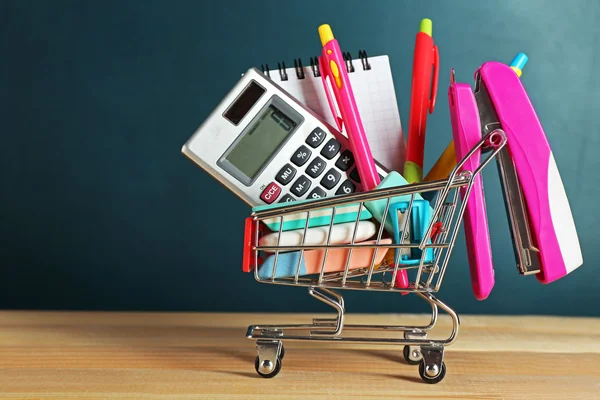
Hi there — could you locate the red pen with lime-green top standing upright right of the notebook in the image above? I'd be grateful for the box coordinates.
[403,18,440,183]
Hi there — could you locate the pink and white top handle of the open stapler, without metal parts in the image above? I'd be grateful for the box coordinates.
[478,62,583,283]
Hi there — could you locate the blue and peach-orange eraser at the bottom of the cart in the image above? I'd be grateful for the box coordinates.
[258,238,392,279]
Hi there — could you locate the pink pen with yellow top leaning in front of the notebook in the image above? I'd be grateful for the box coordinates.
[319,24,380,191]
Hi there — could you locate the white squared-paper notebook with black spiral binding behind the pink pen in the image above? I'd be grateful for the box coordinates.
[261,50,406,173]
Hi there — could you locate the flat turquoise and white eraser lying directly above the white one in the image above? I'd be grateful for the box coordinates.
[252,199,372,231]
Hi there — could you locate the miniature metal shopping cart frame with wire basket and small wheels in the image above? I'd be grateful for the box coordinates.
[245,130,506,383]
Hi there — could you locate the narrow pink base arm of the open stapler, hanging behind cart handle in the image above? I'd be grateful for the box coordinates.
[448,75,495,300]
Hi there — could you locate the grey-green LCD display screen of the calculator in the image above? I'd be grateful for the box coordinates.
[225,104,297,180]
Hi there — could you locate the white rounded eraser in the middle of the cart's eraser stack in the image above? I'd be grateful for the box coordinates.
[258,221,377,250]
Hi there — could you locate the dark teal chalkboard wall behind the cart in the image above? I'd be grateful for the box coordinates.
[0,0,600,316]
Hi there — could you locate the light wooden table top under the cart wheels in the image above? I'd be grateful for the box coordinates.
[0,311,600,399]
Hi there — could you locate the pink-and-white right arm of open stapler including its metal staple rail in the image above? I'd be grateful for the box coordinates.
[474,62,583,283]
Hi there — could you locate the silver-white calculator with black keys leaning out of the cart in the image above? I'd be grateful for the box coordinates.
[181,68,389,207]
